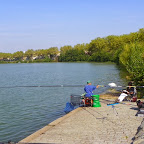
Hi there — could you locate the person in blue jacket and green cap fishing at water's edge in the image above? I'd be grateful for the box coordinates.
[84,81,99,97]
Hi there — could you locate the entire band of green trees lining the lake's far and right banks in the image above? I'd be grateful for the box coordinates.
[0,29,144,88]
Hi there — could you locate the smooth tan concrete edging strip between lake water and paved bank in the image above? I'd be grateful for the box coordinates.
[18,107,82,144]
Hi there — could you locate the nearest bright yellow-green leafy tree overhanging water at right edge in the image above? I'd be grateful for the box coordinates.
[120,43,144,83]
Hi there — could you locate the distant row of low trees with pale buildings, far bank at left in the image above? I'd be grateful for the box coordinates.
[0,47,59,63]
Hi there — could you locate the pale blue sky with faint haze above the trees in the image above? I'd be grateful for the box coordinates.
[0,0,144,53]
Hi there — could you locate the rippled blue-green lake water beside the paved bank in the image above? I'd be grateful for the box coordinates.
[0,63,125,142]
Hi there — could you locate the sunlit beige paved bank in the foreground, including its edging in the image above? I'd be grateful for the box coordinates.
[18,102,143,144]
